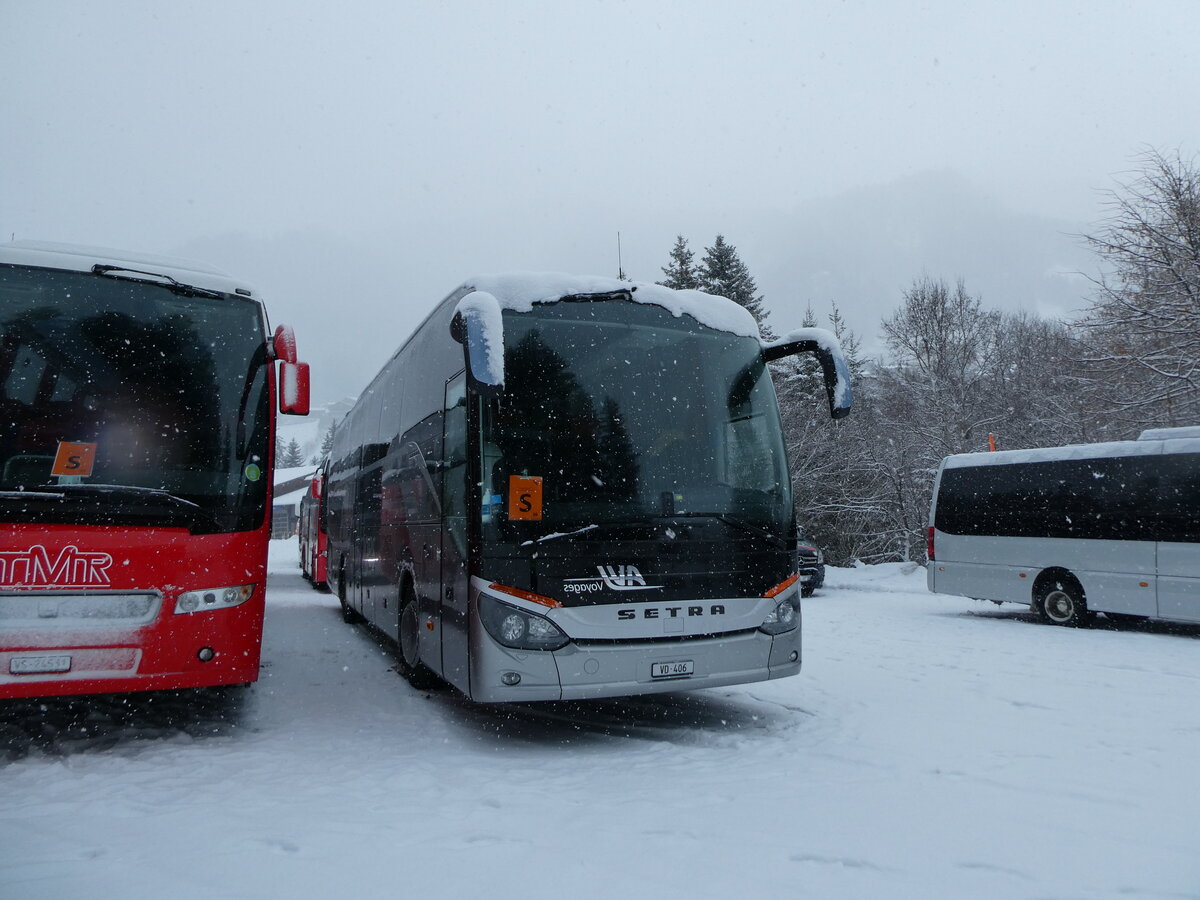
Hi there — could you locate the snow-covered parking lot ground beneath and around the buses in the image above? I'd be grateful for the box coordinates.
[0,540,1200,900]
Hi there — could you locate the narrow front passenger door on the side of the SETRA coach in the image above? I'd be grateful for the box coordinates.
[440,372,470,691]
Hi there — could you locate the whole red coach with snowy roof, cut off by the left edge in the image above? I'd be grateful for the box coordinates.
[0,242,308,698]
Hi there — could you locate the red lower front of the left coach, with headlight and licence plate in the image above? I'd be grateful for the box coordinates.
[0,526,266,698]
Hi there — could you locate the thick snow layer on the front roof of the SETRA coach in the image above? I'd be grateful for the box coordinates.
[463,272,761,340]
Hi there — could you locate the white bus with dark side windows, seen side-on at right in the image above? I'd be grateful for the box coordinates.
[928,427,1200,625]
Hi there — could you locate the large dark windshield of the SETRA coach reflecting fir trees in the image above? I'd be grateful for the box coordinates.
[480,299,792,541]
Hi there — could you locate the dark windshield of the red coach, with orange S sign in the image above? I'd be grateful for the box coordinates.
[0,265,269,533]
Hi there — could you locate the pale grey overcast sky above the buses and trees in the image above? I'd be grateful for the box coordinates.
[0,0,1200,397]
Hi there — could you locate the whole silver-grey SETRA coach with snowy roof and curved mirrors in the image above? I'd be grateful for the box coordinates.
[325,275,850,702]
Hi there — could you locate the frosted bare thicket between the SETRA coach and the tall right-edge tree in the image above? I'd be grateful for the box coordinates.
[773,276,1103,563]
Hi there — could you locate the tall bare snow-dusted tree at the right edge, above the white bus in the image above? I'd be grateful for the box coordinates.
[1080,150,1200,428]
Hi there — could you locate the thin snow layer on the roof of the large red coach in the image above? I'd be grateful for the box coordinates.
[0,241,257,296]
